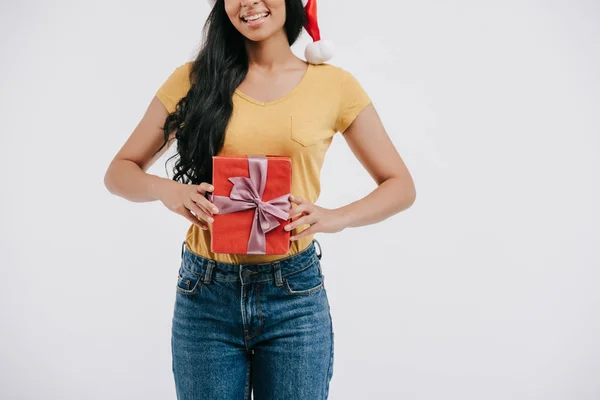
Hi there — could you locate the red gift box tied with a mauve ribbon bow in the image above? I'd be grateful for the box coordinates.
[208,156,292,254]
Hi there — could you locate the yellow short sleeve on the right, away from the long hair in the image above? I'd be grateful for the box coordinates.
[335,68,371,133]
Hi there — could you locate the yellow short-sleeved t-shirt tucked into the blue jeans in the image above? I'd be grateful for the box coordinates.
[156,61,371,264]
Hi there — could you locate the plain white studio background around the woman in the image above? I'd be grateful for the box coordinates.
[0,0,600,400]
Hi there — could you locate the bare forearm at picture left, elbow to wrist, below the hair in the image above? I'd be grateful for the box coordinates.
[104,160,173,203]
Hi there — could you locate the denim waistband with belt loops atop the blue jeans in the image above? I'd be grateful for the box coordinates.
[181,239,323,284]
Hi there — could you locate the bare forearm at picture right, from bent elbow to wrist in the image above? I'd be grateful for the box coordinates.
[335,178,416,228]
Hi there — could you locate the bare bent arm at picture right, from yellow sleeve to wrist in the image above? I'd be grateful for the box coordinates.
[333,104,416,227]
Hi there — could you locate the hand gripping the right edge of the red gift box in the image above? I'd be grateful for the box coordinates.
[284,194,345,240]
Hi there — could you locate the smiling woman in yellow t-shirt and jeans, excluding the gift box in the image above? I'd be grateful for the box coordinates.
[105,0,415,400]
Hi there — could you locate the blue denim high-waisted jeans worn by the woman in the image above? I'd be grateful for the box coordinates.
[171,240,333,400]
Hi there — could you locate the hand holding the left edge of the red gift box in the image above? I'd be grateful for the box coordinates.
[159,180,219,230]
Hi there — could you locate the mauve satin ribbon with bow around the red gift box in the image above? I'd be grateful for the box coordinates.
[208,156,292,254]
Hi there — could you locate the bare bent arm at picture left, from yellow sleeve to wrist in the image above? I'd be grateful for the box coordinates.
[104,97,175,202]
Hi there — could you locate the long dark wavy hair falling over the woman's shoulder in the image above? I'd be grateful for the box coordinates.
[155,0,306,185]
